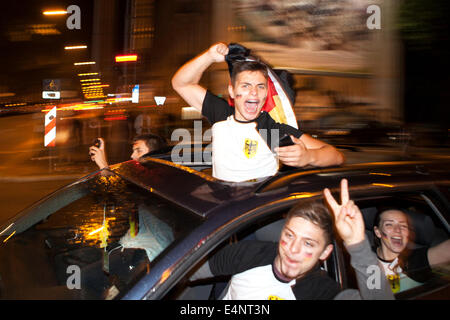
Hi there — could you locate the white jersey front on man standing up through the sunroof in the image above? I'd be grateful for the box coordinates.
[212,115,278,182]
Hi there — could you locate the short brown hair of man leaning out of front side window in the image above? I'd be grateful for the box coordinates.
[286,201,334,245]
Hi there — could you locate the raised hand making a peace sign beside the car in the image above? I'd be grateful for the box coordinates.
[323,179,365,245]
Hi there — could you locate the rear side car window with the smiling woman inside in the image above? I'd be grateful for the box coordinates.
[347,193,450,299]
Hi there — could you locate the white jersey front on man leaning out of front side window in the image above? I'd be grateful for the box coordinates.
[223,264,296,300]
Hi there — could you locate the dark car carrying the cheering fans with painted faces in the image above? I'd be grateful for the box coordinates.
[0,158,450,299]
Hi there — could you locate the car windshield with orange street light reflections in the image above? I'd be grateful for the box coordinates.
[0,171,200,299]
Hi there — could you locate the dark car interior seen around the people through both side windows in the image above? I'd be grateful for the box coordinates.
[164,193,450,300]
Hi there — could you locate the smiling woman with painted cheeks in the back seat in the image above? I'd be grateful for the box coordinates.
[373,209,450,293]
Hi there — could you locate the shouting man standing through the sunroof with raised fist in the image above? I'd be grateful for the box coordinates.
[172,43,344,182]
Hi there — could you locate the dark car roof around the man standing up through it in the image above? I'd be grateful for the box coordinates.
[112,158,450,218]
